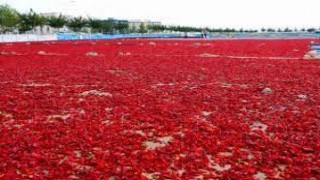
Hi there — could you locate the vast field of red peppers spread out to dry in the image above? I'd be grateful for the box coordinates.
[0,39,320,180]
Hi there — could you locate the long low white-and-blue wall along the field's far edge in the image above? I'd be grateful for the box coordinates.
[0,33,320,42]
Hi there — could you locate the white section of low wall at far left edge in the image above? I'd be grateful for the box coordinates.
[0,34,58,42]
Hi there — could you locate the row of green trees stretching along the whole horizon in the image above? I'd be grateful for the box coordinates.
[0,4,318,34]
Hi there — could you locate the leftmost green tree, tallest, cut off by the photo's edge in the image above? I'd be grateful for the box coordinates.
[0,5,19,33]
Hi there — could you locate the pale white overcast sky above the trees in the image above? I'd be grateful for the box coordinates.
[0,0,320,29]
